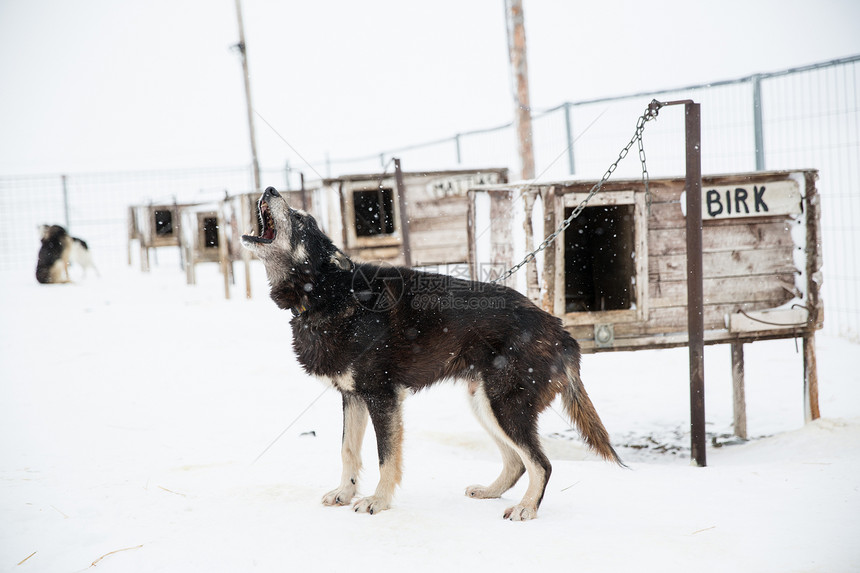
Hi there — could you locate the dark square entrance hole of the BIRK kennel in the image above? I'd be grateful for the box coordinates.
[564,205,636,312]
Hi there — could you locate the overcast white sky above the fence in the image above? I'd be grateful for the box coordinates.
[0,0,860,175]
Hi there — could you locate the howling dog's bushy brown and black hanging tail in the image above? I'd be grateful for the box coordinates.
[561,348,627,468]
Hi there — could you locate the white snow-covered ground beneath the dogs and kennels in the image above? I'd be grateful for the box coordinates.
[0,259,860,572]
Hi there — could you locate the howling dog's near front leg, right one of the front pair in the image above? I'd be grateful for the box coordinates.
[353,389,406,514]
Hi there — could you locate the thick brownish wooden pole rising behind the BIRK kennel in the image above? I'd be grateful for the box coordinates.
[505,0,535,179]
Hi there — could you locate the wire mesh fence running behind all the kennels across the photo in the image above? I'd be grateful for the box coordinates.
[0,56,860,338]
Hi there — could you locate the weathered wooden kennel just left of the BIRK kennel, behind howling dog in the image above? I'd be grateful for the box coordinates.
[318,168,508,266]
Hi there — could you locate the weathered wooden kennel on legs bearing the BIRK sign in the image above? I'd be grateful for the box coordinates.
[469,170,823,437]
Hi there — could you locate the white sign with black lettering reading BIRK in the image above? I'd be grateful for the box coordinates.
[702,180,803,220]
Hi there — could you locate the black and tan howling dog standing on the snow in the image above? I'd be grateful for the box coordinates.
[242,187,623,521]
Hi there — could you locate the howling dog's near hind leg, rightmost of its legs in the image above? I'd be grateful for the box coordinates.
[467,385,552,521]
